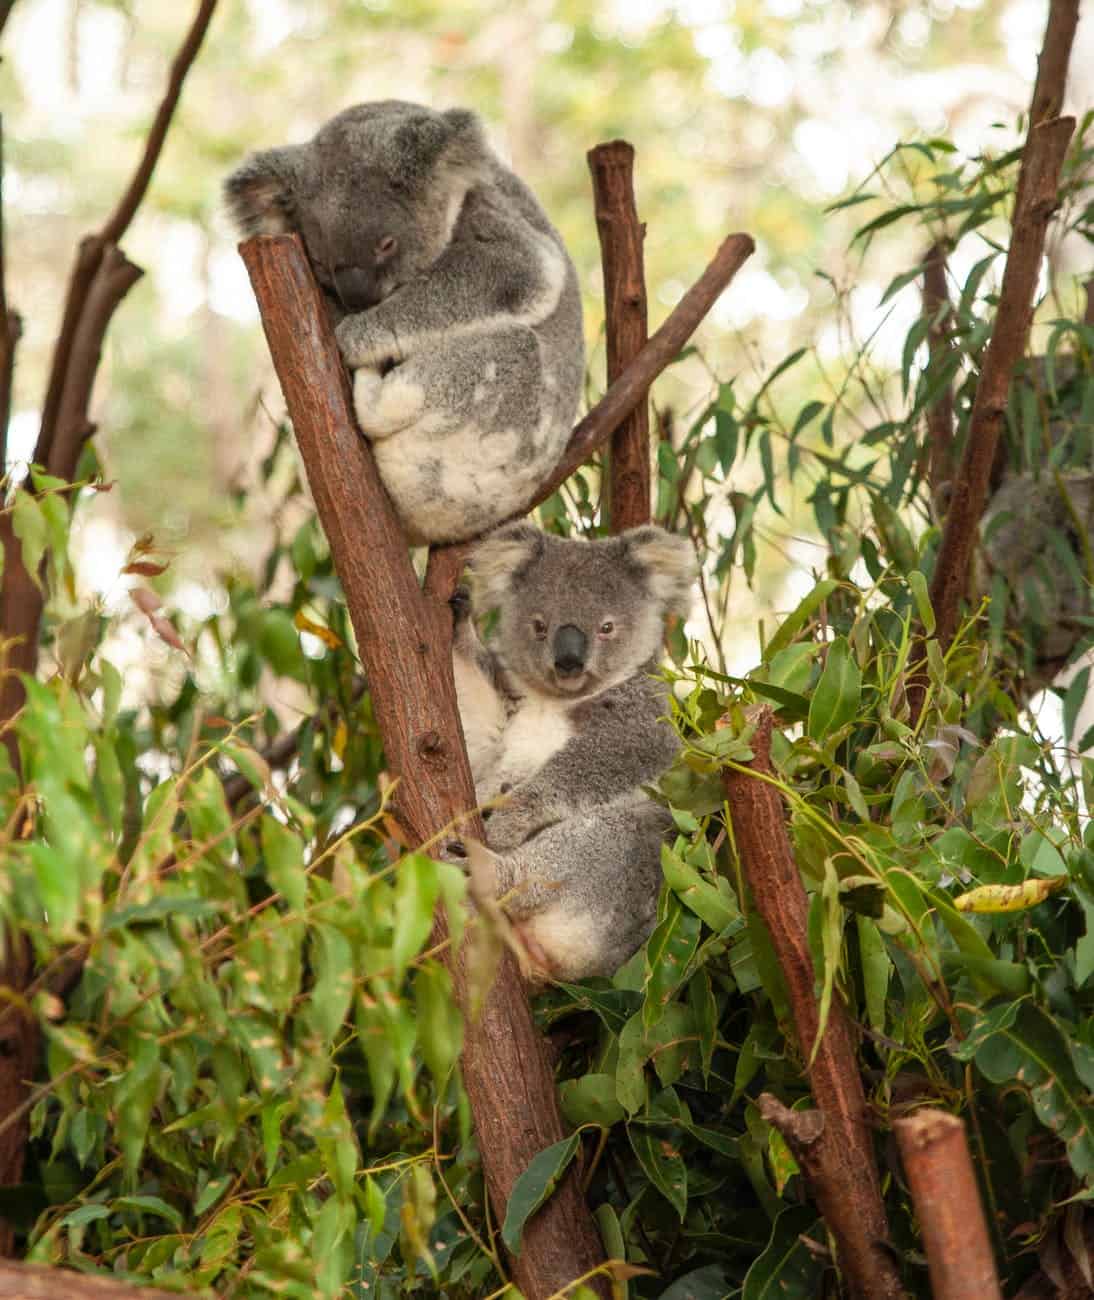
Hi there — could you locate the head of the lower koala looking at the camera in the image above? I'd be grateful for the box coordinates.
[470,524,695,698]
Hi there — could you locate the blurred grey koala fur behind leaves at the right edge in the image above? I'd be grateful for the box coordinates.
[977,473,1094,663]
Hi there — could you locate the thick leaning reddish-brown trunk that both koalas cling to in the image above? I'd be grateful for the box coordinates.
[240,235,607,1300]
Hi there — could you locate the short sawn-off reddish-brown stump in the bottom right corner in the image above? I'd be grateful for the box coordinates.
[893,1110,1003,1300]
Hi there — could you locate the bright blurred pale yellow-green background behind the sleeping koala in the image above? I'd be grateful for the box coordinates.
[0,0,1094,681]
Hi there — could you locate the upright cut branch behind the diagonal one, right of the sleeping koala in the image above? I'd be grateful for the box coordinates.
[587,140,651,533]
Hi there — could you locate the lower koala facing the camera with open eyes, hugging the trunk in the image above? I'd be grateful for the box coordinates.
[447,524,695,979]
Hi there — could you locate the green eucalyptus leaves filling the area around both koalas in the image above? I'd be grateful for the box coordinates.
[0,109,1094,1300]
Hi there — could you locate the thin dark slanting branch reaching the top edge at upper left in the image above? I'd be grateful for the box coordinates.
[34,0,217,465]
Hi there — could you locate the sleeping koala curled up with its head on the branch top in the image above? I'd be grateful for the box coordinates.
[225,100,585,543]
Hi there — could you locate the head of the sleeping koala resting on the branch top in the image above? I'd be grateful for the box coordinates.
[225,99,492,312]
